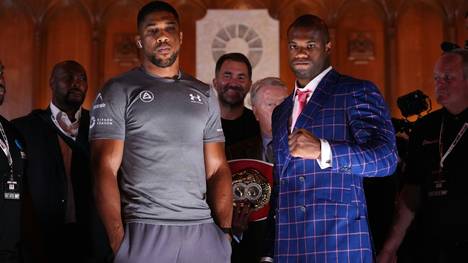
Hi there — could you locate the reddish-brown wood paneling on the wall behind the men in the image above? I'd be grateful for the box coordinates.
[0,0,468,119]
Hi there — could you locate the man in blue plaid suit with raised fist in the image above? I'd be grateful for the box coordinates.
[262,15,397,263]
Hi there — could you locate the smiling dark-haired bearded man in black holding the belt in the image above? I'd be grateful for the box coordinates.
[213,53,260,160]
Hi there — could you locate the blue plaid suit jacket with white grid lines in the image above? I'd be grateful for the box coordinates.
[269,70,397,263]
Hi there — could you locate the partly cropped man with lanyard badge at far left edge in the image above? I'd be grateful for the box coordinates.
[0,61,26,263]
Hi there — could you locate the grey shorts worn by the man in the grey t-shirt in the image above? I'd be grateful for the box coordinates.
[114,223,231,263]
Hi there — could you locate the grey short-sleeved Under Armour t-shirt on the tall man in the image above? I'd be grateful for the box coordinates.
[90,68,224,224]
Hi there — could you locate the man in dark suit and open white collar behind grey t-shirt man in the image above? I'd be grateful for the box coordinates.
[13,60,110,262]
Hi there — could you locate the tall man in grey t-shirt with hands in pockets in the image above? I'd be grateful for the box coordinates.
[90,1,232,263]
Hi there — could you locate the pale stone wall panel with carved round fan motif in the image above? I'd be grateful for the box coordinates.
[196,9,279,83]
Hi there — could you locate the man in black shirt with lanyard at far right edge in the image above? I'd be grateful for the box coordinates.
[378,49,468,263]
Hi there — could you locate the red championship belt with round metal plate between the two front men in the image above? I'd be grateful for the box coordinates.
[228,159,273,221]
